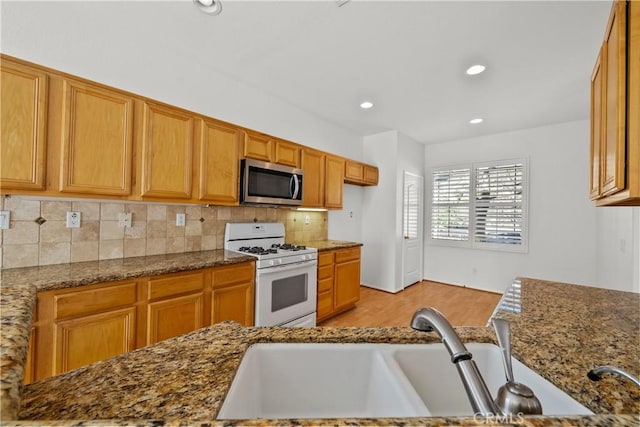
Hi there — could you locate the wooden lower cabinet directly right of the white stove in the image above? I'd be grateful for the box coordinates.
[317,247,360,322]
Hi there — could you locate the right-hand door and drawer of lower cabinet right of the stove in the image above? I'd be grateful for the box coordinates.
[333,248,360,311]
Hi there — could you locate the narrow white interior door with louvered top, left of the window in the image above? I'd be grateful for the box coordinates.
[402,172,423,288]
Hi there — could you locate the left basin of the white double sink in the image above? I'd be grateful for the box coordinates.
[217,344,429,419]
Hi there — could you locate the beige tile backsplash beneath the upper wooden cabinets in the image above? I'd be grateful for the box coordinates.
[0,196,327,268]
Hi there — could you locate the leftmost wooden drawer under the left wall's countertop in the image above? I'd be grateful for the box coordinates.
[53,282,137,319]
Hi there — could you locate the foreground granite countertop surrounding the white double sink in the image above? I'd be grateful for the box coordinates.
[2,252,640,426]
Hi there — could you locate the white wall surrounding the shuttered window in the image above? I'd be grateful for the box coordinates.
[424,120,600,292]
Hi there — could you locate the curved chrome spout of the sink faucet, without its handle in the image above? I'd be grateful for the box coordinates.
[411,307,502,415]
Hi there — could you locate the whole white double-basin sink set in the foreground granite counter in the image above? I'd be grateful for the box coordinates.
[217,343,592,419]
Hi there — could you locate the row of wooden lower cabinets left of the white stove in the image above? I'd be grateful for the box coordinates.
[24,261,255,384]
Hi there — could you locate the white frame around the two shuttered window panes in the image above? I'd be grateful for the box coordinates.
[425,157,530,253]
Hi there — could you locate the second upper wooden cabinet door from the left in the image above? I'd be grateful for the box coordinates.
[60,80,134,195]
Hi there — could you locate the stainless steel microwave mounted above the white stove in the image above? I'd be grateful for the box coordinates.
[240,159,303,206]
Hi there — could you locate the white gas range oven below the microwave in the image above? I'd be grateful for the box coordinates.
[224,222,318,327]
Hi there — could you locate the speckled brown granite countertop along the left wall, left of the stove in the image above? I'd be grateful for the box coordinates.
[0,250,255,420]
